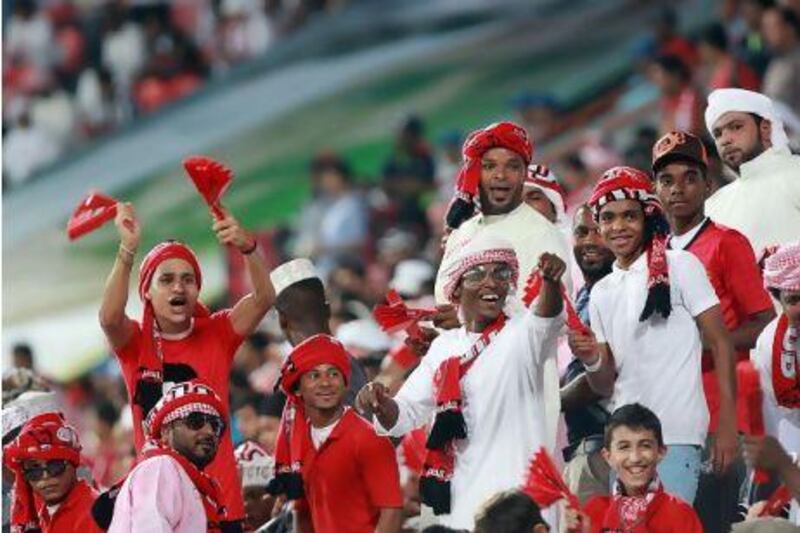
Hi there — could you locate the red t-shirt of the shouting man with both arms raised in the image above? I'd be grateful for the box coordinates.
[115,309,244,520]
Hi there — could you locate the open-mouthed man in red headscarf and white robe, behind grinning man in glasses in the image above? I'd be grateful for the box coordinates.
[436,122,571,451]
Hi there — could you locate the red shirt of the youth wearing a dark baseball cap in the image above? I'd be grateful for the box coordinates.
[685,219,772,433]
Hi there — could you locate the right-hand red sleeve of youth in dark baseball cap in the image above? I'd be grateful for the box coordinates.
[719,230,772,316]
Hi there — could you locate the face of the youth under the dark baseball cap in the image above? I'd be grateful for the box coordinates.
[656,161,711,220]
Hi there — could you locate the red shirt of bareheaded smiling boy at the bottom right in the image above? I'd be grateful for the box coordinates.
[584,492,703,533]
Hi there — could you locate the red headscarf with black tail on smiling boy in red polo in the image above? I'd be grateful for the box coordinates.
[267,334,350,500]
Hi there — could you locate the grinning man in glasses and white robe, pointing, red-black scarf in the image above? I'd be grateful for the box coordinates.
[357,235,566,530]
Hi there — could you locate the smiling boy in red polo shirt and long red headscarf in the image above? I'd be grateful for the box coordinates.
[268,334,403,533]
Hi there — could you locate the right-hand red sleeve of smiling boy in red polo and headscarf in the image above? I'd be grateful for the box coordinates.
[358,428,403,508]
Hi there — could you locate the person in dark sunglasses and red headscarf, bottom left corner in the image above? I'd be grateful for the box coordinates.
[3,413,100,533]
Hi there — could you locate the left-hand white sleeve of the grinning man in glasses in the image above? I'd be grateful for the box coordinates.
[374,339,444,437]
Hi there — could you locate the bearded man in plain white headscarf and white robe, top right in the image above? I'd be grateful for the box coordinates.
[705,89,800,256]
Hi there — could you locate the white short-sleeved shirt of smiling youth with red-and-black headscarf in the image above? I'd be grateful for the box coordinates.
[589,250,719,445]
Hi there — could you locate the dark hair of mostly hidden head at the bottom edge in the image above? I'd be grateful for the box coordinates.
[475,490,547,533]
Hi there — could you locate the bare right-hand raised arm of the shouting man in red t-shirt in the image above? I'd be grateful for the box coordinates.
[212,213,275,336]
